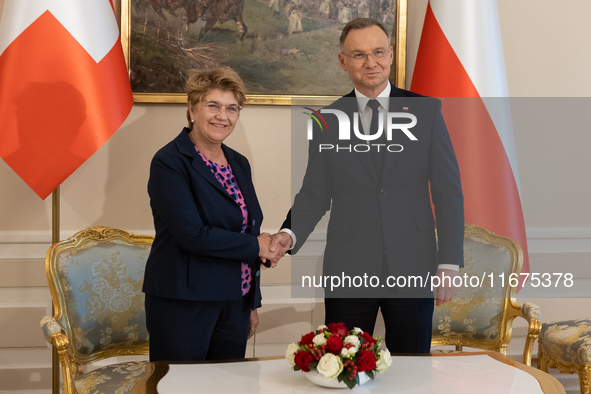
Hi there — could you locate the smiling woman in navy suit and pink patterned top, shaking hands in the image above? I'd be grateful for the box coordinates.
[143,68,281,361]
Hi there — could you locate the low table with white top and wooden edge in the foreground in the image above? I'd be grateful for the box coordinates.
[133,352,564,394]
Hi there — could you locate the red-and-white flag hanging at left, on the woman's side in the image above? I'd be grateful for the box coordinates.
[0,0,133,198]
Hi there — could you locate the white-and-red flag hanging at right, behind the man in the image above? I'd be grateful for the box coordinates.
[411,0,529,273]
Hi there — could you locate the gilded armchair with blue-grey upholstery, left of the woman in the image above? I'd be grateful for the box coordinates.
[41,226,153,394]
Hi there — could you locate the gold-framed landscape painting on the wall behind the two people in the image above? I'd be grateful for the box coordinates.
[121,0,407,105]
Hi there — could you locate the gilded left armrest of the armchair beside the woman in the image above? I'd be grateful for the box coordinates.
[39,316,78,394]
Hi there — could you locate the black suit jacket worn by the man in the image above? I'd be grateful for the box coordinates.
[282,86,464,294]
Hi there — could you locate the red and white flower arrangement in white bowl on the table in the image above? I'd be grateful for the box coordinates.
[285,323,392,389]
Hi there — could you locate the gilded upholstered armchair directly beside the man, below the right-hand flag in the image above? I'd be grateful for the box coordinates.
[431,224,541,365]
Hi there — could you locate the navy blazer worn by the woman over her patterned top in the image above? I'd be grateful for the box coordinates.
[143,128,263,308]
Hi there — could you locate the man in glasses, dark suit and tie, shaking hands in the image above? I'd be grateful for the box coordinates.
[272,18,464,353]
